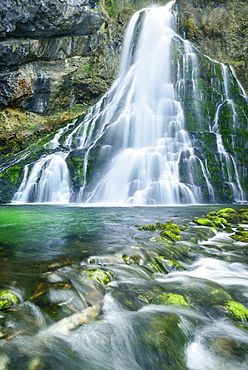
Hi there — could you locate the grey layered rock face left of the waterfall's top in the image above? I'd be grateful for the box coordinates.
[0,0,119,115]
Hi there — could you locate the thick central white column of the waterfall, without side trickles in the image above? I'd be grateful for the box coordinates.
[82,2,200,204]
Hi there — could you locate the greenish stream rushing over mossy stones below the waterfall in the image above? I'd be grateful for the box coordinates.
[0,204,248,370]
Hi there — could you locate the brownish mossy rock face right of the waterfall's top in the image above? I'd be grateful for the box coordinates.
[176,0,248,92]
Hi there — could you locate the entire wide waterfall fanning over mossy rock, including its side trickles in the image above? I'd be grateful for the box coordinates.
[8,1,247,204]
